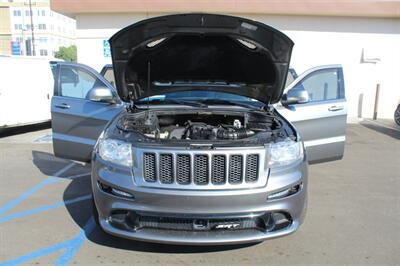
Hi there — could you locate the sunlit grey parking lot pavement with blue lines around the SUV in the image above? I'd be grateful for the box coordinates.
[0,121,400,265]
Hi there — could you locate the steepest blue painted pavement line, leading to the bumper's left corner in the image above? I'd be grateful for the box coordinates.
[54,216,96,266]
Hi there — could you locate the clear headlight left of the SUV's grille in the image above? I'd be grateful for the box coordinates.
[98,138,132,167]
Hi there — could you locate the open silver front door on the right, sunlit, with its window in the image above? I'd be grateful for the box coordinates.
[276,65,347,163]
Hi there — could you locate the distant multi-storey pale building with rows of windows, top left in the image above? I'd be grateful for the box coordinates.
[2,0,76,56]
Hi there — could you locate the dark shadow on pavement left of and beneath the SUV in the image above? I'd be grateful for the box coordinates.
[32,151,257,253]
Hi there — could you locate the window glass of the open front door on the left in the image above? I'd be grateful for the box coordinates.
[60,66,99,99]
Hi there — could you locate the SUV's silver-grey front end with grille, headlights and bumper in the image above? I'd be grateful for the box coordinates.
[92,117,307,245]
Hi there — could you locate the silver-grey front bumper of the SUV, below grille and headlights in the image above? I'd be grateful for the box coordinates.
[92,155,307,245]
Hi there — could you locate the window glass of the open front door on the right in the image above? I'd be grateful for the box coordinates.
[293,69,344,102]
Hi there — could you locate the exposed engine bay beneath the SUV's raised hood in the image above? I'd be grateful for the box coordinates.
[117,110,288,141]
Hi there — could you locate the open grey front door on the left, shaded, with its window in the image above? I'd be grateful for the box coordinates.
[51,63,123,161]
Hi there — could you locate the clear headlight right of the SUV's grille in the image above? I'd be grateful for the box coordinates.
[268,139,304,167]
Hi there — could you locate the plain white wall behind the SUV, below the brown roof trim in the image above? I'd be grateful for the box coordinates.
[76,13,400,118]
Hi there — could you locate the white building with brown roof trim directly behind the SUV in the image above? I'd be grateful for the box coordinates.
[52,0,400,119]
